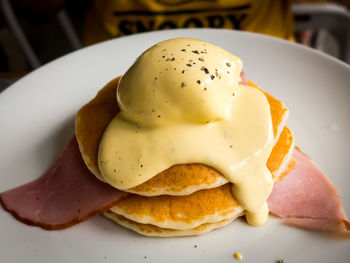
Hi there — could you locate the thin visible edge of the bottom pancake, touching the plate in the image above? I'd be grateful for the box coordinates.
[104,211,239,237]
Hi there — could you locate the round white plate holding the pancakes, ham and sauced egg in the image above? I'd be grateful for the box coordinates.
[0,29,350,263]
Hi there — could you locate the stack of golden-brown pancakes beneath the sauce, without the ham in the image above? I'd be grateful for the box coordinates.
[76,78,295,237]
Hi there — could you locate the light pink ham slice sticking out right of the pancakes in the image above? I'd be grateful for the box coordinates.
[268,149,350,232]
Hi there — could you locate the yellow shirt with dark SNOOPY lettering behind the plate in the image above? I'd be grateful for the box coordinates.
[85,0,293,44]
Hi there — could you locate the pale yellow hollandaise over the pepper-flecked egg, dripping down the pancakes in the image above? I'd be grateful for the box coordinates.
[98,38,273,225]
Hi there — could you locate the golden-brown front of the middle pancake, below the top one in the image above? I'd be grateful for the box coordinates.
[110,183,243,230]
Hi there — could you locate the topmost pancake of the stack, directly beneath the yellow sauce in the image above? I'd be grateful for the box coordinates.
[75,77,288,196]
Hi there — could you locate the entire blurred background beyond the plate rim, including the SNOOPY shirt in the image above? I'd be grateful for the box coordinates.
[0,0,350,92]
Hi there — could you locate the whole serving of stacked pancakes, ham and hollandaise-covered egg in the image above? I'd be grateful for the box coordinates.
[0,38,350,236]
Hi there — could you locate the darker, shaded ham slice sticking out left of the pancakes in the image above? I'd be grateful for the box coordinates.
[0,137,125,230]
